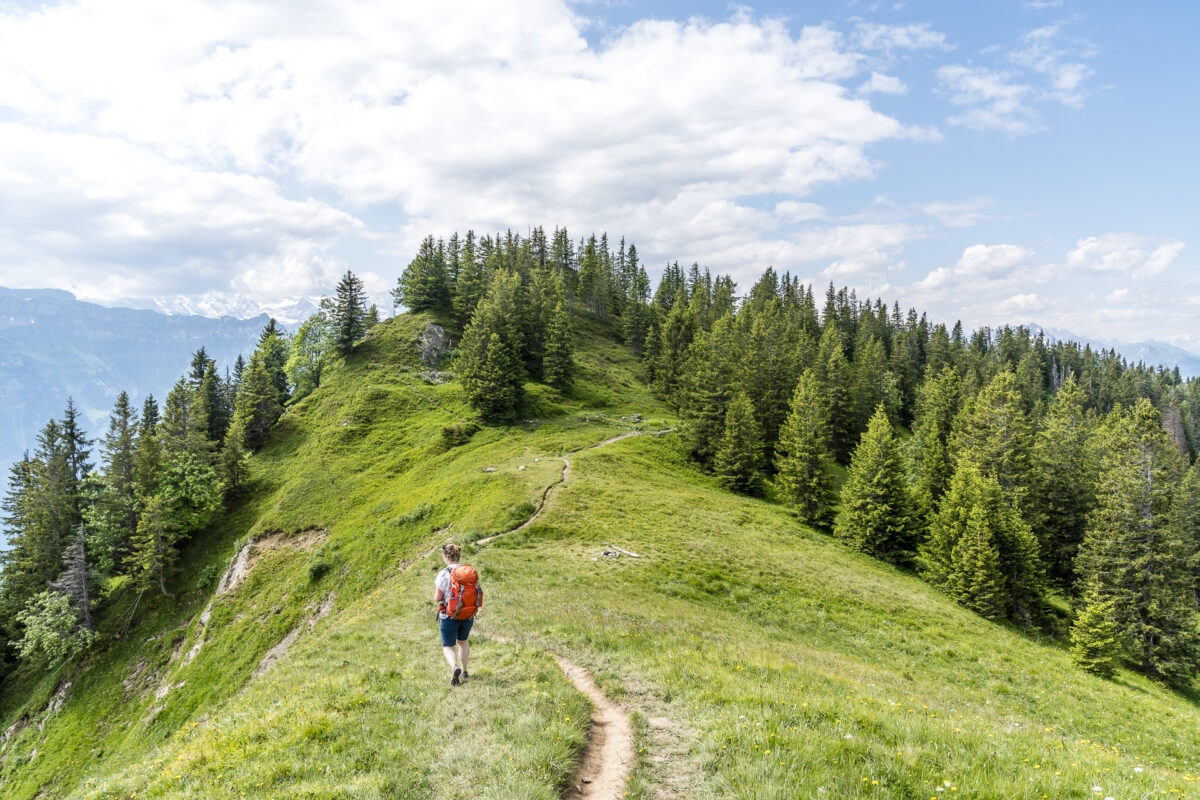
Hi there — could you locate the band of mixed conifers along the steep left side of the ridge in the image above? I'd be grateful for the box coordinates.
[0,271,378,672]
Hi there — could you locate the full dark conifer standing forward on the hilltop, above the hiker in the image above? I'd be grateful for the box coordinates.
[458,270,524,421]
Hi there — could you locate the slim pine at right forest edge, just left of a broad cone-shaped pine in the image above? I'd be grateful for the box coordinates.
[775,369,835,525]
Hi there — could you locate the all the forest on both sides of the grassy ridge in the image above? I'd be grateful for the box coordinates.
[0,228,1200,685]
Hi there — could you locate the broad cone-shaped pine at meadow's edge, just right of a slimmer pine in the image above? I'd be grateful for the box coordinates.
[834,405,916,563]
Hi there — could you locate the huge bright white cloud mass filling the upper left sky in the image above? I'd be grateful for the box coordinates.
[0,0,926,307]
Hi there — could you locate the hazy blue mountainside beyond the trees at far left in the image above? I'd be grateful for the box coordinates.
[0,287,268,482]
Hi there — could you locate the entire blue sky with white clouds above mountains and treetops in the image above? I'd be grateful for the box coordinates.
[0,0,1200,348]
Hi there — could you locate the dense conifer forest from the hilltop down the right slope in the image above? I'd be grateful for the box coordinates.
[427,228,1200,681]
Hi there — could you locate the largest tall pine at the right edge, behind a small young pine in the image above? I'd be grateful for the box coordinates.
[1076,399,1200,680]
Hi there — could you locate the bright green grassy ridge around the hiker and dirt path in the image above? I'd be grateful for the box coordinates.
[0,318,1200,799]
